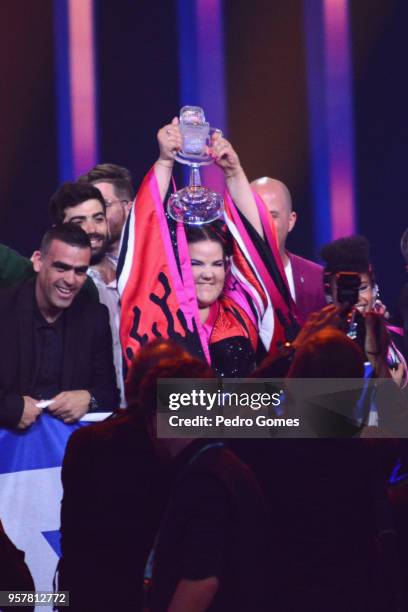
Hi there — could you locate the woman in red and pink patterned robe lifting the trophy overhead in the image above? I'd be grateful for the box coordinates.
[119,107,297,377]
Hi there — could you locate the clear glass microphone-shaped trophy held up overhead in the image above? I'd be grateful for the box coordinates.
[167,106,224,225]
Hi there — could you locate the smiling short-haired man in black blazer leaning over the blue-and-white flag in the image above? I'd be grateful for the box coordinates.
[0,223,119,429]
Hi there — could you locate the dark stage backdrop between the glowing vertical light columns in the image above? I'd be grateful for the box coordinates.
[0,0,408,307]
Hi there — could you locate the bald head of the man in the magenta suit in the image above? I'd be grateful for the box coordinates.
[251,176,296,257]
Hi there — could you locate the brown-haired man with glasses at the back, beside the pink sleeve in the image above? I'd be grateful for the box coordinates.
[78,164,134,263]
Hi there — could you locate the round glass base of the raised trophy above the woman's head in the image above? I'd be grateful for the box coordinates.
[167,185,224,225]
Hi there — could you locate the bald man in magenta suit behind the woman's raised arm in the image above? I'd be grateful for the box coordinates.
[251,177,326,323]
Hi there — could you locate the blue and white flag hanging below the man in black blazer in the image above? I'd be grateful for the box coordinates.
[0,411,108,612]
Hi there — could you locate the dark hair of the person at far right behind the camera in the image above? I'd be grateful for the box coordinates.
[320,236,372,274]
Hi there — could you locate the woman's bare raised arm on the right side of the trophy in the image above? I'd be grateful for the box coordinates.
[210,134,263,236]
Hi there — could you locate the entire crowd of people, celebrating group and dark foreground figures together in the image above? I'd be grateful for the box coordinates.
[0,118,408,612]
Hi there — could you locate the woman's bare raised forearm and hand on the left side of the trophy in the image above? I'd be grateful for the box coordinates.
[154,117,181,200]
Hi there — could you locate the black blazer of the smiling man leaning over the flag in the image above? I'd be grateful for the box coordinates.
[0,279,119,427]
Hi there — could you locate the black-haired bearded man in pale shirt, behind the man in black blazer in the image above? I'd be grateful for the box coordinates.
[49,181,126,408]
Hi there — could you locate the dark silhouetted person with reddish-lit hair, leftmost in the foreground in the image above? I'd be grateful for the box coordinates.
[59,340,192,612]
